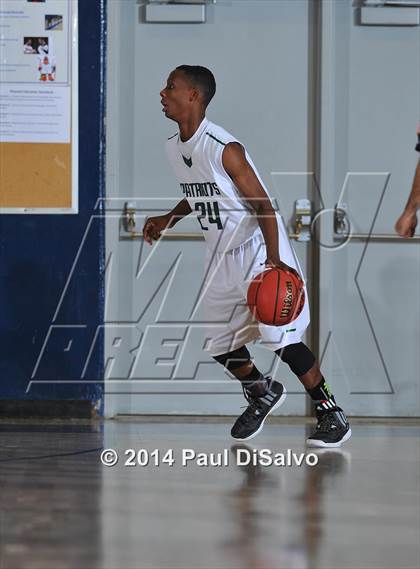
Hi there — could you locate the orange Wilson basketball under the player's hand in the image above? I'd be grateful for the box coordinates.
[247,268,305,326]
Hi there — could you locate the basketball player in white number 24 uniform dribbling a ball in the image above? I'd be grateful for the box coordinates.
[143,65,351,447]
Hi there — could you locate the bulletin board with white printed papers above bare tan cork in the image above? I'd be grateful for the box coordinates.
[0,0,78,214]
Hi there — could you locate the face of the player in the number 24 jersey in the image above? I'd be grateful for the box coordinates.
[160,70,194,121]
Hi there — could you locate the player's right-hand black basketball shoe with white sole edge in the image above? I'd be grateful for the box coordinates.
[306,407,351,448]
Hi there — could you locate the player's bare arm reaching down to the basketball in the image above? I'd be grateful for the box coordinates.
[222,142,299,276]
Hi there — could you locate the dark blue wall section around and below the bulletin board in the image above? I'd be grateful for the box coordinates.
[0,0,106,409]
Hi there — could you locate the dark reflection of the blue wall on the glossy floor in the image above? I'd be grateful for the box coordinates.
[0,423,103,569]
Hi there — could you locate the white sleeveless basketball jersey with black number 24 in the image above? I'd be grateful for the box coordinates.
[166,118,268,252]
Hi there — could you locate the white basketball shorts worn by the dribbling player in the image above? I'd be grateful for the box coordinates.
[201,219,310,356]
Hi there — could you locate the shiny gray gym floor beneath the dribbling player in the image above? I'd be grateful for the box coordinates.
[0,418,420,569]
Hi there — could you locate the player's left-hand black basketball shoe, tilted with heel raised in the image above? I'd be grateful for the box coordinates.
[230,377,286,441]
